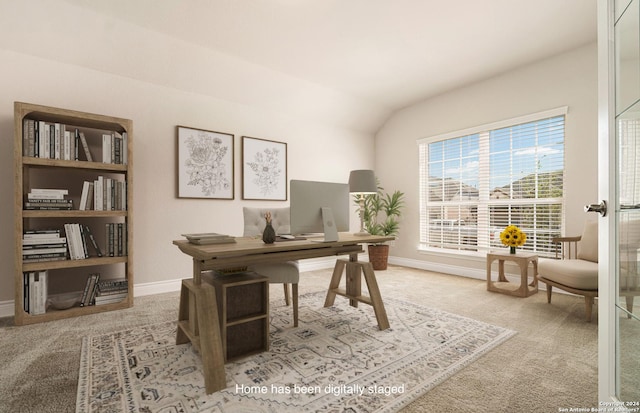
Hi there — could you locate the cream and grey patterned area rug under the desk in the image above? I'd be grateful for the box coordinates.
[76,292,515,413]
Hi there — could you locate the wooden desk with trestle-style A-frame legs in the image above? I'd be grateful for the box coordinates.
[173,233,393,394]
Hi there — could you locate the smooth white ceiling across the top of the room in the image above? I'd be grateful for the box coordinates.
[63,0,596,110]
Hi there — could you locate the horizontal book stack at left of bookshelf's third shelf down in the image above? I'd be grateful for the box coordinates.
[22,229,67,262]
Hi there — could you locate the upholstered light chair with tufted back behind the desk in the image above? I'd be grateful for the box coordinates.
[242,207,300,327]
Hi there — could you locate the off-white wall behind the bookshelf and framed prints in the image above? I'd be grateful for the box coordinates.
[0,49,374,306]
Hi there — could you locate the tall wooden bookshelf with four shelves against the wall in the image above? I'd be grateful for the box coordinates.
[14,102,133,325]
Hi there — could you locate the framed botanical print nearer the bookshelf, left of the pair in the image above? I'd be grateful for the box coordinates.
[177,126,234,199]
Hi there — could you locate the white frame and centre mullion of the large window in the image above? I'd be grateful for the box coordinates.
[417,106,569,255]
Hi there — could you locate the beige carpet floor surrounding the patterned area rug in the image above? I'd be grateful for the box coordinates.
[0,267,597,412]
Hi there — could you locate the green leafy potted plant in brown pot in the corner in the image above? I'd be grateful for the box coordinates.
[354,185,404,270]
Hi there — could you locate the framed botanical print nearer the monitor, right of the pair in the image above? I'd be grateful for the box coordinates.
[242,136,287,201]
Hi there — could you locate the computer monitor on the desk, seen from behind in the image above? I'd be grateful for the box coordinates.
[289,179,349,242]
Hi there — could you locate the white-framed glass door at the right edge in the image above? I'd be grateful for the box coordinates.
[598,0,640,400]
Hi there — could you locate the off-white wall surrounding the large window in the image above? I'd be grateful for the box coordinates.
[376,43,597,276]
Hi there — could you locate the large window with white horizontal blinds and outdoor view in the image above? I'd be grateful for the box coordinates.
[418,108,566,256]
